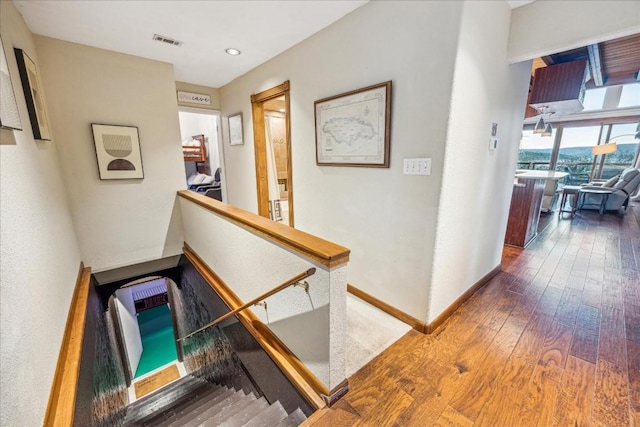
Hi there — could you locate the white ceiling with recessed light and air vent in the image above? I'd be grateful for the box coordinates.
[13,0,533,87]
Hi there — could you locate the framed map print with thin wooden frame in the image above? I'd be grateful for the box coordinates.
[314,81,391,168]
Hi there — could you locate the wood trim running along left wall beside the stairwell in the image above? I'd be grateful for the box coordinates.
[43,262,91,427]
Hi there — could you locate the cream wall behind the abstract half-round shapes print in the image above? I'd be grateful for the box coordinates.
[35,36,186,271]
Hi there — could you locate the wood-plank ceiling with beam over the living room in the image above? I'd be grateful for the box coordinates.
[533,34,640,88]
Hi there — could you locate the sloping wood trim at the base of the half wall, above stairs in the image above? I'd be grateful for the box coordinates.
[184,243,331,410]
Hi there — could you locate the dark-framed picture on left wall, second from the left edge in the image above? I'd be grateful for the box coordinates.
[13,48,51,141]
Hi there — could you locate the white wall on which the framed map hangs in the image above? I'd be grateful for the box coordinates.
[220,1,462,320]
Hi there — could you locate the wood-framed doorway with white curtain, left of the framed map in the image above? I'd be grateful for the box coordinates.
[251,81,294,227]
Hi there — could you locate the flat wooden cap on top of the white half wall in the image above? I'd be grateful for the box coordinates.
[178,190,350,268]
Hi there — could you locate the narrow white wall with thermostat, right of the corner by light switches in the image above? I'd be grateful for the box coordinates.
[427,1,531,323]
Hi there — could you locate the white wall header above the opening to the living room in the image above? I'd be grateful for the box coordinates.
[508,0,640,63]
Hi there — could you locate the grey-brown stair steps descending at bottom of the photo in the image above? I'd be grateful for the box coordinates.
[123,375,306,427]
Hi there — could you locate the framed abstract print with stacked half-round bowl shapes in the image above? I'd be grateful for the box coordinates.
[91,123,144,180]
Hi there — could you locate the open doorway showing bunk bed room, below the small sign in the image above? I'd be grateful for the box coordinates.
[178,107,226,201]
